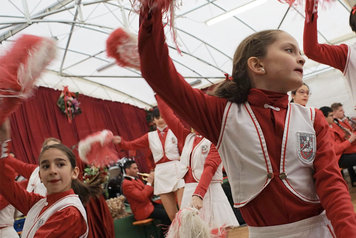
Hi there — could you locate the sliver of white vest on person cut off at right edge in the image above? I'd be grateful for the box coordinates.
[343,43,356,104]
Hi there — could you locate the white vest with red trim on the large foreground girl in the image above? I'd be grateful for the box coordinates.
[217,102,319,207]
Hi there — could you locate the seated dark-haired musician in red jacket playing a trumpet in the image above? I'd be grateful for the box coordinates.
[122,160,171,225]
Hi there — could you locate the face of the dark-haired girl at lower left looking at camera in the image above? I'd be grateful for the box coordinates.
[40,148,79,194]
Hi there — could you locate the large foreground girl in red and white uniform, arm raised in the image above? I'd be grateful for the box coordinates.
[131,4,356,237]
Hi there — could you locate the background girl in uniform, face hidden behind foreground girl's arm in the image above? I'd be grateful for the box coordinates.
[156,96,239,228]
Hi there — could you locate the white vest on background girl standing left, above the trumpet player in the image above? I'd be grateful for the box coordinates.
[148,130,179,163]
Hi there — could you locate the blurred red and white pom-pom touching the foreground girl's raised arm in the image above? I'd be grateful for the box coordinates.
[106,28,140,70]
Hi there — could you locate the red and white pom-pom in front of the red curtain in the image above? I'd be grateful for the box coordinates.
[78,130,118,167]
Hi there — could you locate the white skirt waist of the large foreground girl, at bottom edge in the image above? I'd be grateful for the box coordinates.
[248,211,336,238]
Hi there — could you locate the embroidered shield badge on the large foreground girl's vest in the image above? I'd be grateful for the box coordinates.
[297,132,316,164]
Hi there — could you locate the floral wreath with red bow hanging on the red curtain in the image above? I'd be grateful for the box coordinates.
[57,86,82,123]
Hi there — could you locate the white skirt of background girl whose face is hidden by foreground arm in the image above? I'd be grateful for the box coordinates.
[181,183,239,228]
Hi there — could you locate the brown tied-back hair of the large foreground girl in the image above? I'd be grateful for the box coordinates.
[214,30,282,103]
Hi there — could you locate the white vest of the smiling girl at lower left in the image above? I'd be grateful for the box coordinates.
[21,194,89,238]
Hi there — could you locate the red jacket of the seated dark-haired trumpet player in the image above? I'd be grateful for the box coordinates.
[122,177,154,220]
